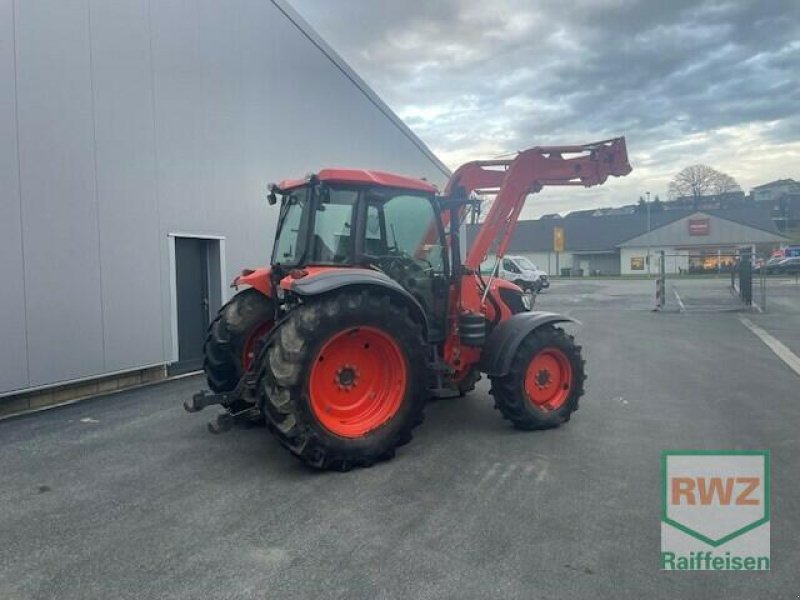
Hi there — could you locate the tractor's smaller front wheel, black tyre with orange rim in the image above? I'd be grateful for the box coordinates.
[491,325,586,430]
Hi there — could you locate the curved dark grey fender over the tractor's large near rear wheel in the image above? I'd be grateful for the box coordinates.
[288,267,428,339]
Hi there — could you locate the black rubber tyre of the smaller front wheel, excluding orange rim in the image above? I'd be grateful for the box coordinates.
[490,325,586,430]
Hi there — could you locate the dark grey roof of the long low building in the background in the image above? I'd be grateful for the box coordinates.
[467,207,780,254]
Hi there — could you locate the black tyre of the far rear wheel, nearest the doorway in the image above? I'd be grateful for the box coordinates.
[203,288,274,412]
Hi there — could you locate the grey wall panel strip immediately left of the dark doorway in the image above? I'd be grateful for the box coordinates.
[90,0,164,371]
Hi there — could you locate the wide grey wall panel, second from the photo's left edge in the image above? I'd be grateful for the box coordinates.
[15,0,103,385]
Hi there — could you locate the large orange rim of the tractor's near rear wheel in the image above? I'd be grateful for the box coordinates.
[309,327,407,438]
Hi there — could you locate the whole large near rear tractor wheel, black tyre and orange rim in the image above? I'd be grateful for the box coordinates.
[259,291,426,471]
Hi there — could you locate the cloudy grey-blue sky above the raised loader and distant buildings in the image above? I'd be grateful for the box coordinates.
[290,0,800,217]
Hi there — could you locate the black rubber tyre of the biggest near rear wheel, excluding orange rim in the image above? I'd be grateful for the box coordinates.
[259,291,427,471]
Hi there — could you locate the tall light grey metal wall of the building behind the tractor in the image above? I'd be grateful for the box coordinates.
[0,0,447,393]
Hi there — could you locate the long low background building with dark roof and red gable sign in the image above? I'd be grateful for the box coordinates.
[467,208,789,275]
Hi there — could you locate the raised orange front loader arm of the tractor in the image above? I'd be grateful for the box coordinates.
[445,137,631,269]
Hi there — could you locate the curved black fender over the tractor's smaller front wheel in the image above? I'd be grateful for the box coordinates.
[478,311,580,377]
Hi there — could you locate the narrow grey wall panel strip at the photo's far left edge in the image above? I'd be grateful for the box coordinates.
[0,0,28,393]
